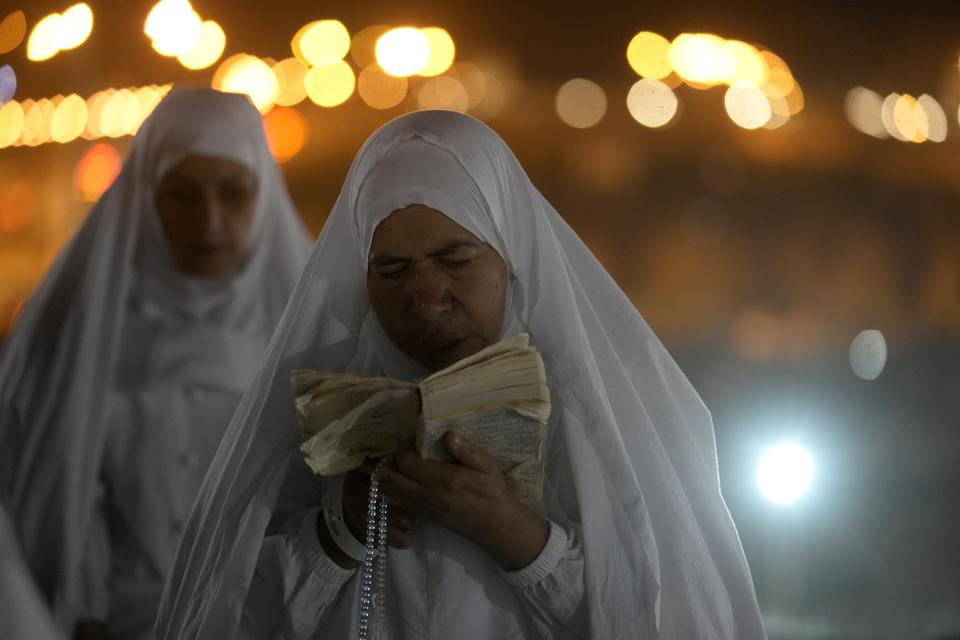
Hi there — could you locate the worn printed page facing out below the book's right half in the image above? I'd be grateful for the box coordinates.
[417,407,546,504]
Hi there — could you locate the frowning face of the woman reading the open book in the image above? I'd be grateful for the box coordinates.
[367,205,507,372]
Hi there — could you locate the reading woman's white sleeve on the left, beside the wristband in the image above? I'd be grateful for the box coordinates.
[239,507,356,640]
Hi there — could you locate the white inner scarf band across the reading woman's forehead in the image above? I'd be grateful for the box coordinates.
[355,138,509,264]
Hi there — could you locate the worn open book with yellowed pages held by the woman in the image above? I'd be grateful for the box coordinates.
[291,333,550,503]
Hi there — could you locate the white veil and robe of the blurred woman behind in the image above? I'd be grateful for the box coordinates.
[0,89,310,629]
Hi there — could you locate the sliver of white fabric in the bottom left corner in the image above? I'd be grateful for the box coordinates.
[0,504,63,640]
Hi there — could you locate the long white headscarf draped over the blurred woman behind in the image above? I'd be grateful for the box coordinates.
[0,89,310,625]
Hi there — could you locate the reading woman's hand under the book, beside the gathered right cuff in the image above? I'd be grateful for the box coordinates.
[381,431,550,570]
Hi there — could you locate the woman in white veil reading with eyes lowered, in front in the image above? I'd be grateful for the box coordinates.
[157,111,765,640]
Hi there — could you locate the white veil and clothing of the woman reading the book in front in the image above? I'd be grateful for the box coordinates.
[157,111,765,640]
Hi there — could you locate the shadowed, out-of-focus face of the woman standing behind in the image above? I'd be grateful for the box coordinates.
[155,155,257,278]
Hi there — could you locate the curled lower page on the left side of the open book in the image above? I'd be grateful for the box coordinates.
[300,389,420,475]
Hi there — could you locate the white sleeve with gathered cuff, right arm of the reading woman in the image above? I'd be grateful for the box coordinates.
[501,521,589,638]
